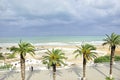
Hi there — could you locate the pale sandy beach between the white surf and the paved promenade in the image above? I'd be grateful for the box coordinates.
[0,44,120,67]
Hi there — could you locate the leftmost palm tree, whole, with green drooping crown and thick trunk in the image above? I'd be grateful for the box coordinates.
[10,41,35,80]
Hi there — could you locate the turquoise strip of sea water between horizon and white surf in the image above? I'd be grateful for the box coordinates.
[0,36,105,43]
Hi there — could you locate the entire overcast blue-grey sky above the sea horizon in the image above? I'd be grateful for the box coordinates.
[0,0,120,37]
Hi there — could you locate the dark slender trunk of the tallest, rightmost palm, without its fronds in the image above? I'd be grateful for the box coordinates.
[109,46,116,79]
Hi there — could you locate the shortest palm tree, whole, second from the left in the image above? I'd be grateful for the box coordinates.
[42,49,66,80]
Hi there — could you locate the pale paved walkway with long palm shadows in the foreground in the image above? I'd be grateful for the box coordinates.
[0,62,120,80]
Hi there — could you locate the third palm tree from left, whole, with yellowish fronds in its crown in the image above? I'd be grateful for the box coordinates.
[74,44,97,80]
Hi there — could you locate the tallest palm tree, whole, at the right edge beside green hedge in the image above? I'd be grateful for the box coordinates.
[103,33,120,79]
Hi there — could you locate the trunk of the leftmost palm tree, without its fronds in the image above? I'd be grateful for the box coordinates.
[20,54,25,80]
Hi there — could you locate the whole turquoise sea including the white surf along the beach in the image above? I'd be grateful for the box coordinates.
[0,36,105,46]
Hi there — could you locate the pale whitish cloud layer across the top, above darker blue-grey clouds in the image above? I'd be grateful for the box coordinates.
[1,0,120,20]
